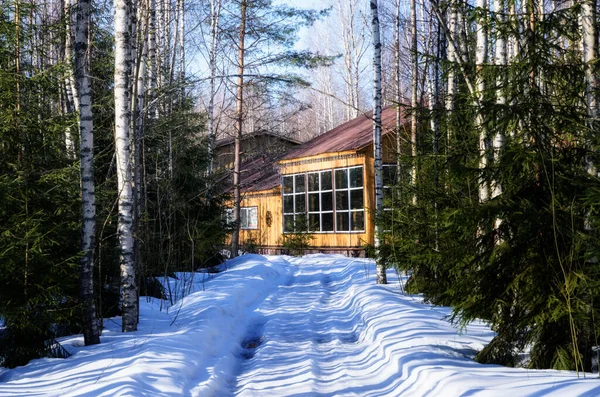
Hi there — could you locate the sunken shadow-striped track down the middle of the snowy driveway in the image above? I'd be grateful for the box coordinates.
[234,257,362,396]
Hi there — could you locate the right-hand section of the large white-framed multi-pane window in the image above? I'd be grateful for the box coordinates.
[335,167,365,232]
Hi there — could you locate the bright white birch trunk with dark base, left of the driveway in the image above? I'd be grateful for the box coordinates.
[114,0,138,332]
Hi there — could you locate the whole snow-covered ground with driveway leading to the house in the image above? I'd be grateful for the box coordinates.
[0,255,600,397]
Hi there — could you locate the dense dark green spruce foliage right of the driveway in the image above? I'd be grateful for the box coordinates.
[384,2,600,371]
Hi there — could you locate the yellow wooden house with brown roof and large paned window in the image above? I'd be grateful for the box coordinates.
[234,107,404,254]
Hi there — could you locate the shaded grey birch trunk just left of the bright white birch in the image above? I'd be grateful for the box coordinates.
[74,0,100,346]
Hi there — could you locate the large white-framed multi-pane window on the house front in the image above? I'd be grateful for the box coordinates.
[283,166,365,232]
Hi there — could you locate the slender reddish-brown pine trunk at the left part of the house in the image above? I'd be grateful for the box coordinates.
[231,0,248,258]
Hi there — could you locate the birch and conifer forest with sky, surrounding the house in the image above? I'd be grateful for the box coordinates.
[0,0,600,378]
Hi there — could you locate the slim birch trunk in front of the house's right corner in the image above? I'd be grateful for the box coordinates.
[370,0,387,284]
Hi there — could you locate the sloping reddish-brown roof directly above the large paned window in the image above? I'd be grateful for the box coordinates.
[281,106,396,160]
